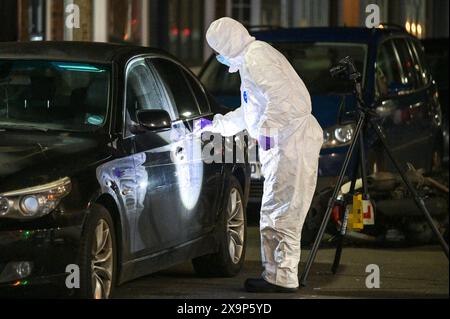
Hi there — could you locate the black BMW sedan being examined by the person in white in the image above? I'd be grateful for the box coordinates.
[0,42,250,298]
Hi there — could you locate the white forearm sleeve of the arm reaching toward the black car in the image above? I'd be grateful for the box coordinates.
[208,107,247,136]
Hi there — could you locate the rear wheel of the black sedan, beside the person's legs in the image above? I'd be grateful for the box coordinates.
[192,176,247,277]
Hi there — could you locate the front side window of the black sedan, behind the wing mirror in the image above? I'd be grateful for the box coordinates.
[125,59,176,131]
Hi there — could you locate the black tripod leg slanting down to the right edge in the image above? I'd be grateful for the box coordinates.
[369,121,448,259]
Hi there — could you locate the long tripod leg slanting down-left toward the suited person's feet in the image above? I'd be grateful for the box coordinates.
[300,113,366,286]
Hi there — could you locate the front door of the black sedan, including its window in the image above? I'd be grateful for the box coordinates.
[124,58,188,257]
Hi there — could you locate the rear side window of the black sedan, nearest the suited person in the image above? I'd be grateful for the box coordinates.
[150,58,200,120]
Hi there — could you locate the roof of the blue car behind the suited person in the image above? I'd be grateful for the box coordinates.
[252,27,409,44]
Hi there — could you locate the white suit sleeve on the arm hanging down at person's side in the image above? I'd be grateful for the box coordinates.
[245,50,292,132]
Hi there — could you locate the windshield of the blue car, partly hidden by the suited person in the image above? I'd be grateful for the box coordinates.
[201,42,367,96]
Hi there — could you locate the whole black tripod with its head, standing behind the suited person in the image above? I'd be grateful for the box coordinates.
[300,57,448,286]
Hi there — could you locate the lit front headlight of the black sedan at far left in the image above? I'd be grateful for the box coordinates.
[0,177,72,219]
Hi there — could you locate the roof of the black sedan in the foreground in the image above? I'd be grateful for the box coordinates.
[0,41,168,63]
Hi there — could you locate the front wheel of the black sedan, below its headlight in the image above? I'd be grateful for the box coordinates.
[78,205,117,299]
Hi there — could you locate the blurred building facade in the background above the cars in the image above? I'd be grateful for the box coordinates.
[0,0,449,66]
